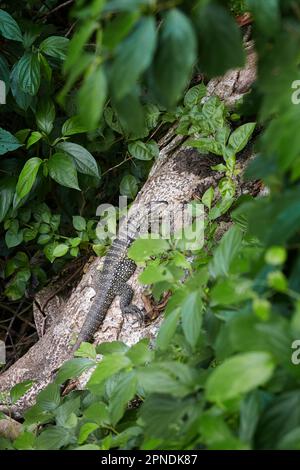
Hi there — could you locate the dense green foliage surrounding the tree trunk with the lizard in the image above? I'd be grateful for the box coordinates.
[0,0,300,449]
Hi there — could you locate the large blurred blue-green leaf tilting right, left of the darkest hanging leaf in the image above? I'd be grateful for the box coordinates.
[111,16,156,100]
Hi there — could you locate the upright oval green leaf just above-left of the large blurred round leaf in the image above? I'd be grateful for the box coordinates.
[181,291,203,348]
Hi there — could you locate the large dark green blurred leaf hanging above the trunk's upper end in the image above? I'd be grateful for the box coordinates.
[195,3,245,77]
